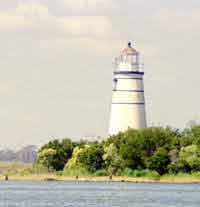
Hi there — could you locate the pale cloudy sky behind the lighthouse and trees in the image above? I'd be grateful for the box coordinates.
[0,0,200,148]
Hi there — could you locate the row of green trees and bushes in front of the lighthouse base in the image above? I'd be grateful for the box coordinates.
[37,126,200,176]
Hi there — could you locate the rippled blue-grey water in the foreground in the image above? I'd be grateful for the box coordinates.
[0,181,200,207]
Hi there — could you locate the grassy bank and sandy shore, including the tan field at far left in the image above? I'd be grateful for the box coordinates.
[0,162,200,183]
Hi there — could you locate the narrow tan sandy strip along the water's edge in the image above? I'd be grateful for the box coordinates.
[0,175,200,184]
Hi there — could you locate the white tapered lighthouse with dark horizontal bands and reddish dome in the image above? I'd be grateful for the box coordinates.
[109,42,147,135]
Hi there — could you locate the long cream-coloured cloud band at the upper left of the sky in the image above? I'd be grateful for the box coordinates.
[0,4,112,39]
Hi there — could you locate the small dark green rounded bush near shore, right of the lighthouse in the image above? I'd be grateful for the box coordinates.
[147,147,170,175]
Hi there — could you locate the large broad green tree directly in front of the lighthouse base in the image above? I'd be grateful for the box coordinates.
[105,127,177,169]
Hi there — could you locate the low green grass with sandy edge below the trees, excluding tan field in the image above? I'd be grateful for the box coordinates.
[0,168,200,183]
